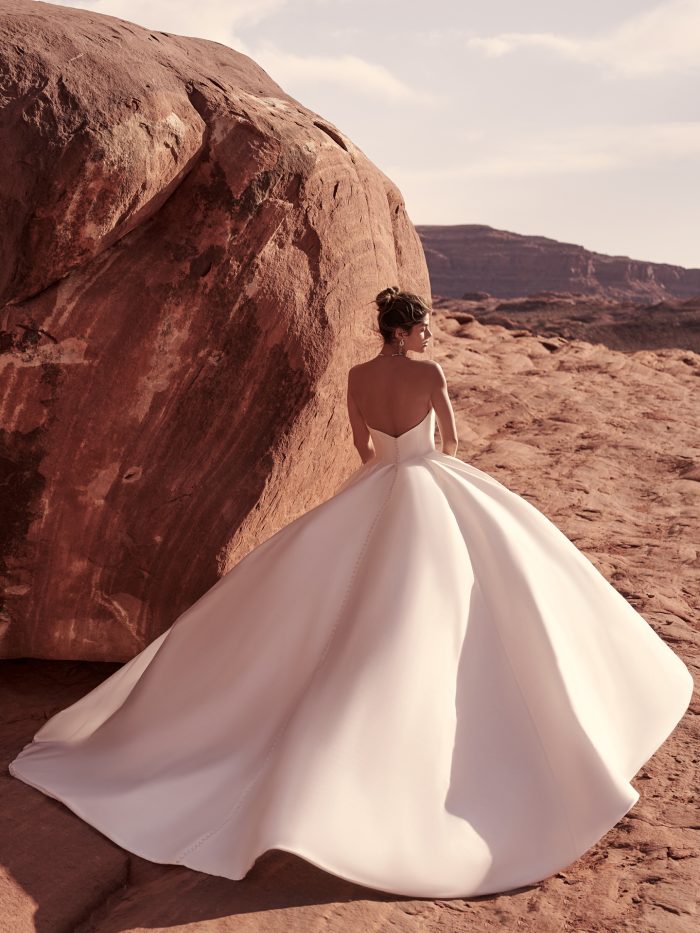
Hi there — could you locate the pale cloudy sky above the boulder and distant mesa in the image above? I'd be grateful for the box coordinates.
[42,0,700,268]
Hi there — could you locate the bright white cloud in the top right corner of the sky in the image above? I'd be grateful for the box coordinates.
[466,0,700,77]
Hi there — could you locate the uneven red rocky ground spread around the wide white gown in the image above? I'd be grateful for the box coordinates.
[0,310,700,933]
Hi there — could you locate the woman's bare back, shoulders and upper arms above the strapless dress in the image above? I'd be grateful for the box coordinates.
[348,356,457,459]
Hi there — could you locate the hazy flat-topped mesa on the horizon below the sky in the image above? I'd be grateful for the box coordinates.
[416,224,700,302]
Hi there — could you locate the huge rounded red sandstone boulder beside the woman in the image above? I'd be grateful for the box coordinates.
[0,0,429,661]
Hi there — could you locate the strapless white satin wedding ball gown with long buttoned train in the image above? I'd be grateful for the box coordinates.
[10,410,693,898]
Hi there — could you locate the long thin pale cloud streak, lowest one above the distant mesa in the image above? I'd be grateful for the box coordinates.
[384,121,700,183]
